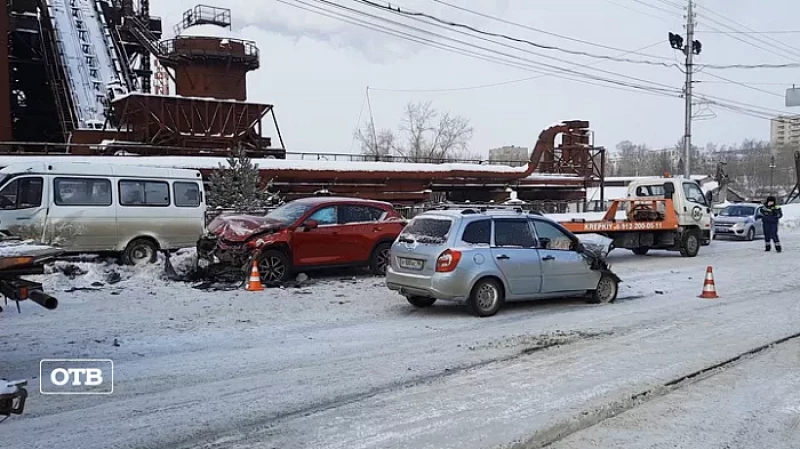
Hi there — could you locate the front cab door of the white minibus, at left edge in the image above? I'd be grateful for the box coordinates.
[0,176,47,239]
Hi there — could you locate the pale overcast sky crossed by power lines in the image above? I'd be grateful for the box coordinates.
[151,0,800,153]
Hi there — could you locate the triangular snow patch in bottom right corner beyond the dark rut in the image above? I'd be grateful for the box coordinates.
[552,340,800,449]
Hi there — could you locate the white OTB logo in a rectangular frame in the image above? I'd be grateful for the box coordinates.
[39,359,114,394]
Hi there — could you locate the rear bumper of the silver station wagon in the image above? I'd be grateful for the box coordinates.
[386,267,470,303]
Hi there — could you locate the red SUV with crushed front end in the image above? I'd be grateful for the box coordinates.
[197,197,406,284]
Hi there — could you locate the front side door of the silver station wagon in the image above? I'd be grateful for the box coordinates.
[531,219,599,293]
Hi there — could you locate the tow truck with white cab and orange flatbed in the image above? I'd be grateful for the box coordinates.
[561,177,712,257]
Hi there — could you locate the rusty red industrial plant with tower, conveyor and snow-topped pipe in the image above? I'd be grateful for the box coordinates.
[0,0,604,206]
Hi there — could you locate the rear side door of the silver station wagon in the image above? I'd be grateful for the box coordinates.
[491,218,542,297]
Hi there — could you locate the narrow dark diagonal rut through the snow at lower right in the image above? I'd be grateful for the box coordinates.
[506,332,800,449]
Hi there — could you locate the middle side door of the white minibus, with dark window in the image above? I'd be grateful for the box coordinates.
[47,176,117,252]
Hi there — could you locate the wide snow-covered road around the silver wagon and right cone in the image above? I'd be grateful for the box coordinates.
[0,234,800,449]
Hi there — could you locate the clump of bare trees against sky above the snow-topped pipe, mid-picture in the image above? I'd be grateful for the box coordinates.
[355,102,480,162]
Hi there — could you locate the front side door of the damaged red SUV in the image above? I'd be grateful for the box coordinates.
[292,205,344,266]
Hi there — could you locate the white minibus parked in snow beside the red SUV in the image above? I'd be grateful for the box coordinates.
[0,157,206,264]
